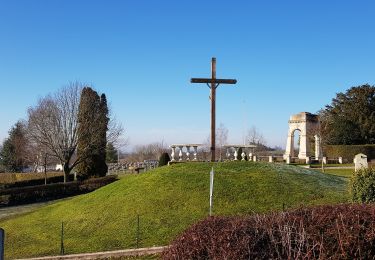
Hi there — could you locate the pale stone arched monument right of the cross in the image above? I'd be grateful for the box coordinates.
[284,112,321,159]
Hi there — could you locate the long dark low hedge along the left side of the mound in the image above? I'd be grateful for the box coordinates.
[0,175,117,206]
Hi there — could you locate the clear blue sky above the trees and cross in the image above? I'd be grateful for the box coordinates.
[0,0,375,150]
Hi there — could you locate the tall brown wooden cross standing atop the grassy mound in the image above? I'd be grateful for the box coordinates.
[190,58,237,162]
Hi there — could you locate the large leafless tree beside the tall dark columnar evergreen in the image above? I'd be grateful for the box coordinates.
[28,82,122,182]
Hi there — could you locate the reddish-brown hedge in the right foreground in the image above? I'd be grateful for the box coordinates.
[162,204,375,259]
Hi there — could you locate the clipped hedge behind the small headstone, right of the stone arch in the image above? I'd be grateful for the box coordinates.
[324,144,375,162]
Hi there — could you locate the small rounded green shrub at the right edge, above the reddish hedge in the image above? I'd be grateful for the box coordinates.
[350,168,375,203]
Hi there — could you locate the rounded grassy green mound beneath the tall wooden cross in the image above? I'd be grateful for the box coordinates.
[0,162,349,259]
